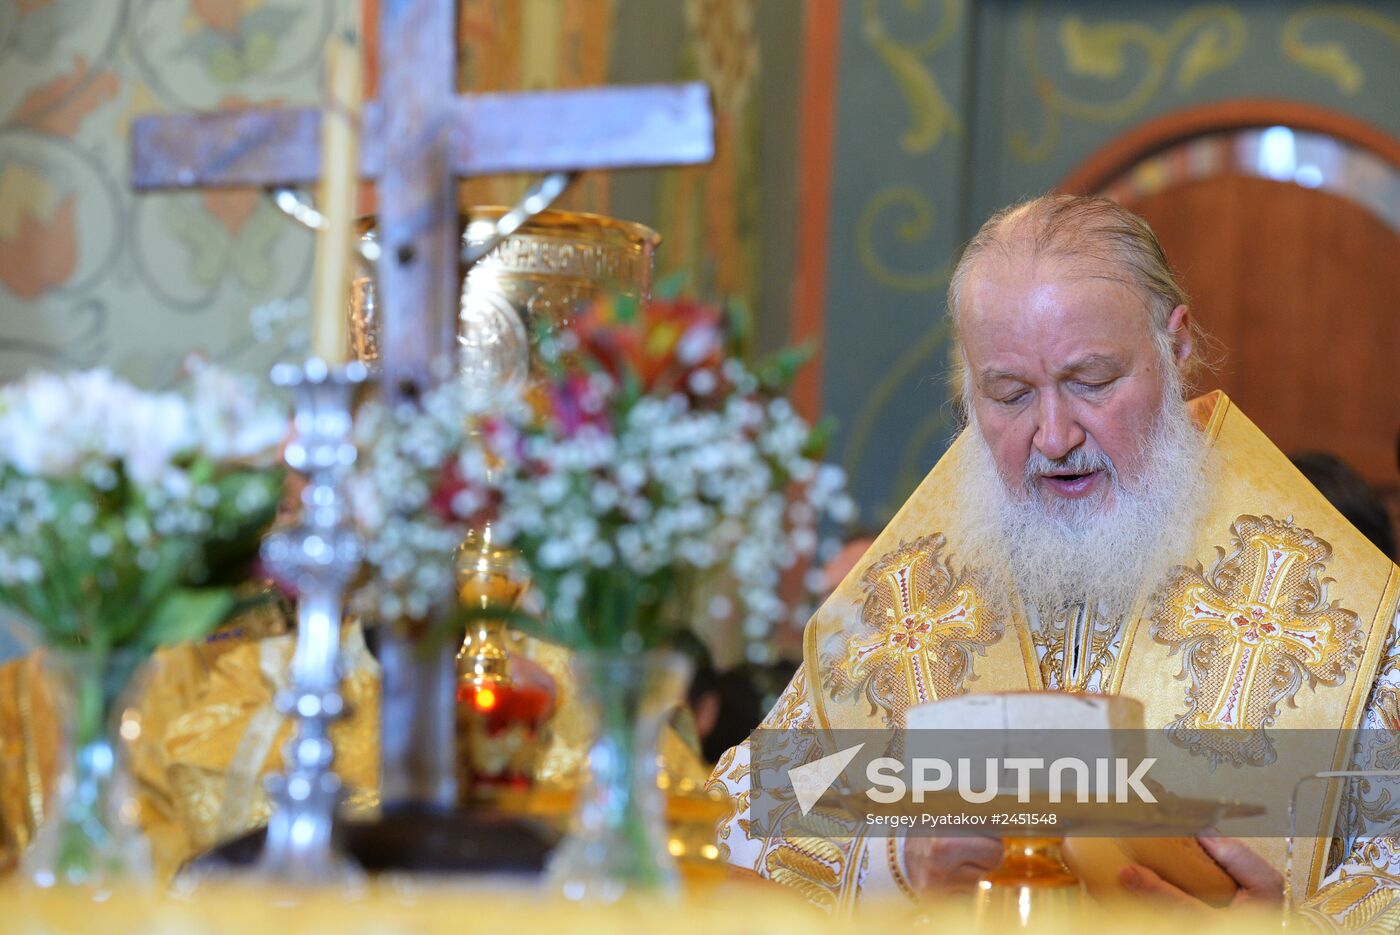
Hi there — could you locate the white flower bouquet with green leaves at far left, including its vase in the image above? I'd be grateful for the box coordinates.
[0,365,287,883]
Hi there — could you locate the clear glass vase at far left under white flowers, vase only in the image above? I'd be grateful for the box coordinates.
[21,649,153,889]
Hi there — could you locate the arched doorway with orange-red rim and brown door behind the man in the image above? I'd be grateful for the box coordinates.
[1061,101,1400,529]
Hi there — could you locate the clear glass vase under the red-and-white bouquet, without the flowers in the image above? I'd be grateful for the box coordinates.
[549,651,690,903]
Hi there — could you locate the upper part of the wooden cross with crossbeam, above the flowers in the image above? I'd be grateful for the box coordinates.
[132,0,714,396]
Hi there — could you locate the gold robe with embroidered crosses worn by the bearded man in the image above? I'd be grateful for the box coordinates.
[711,392,1400,924]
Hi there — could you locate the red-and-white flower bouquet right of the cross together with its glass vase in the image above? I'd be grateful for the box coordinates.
[462,292,853,900]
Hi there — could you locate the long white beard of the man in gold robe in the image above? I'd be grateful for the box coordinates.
[962,386,1205,623]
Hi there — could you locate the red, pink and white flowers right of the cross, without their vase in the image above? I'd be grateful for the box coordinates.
[478,297,854,662]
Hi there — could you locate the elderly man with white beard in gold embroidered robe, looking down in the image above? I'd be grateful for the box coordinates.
[711,195,1400,927]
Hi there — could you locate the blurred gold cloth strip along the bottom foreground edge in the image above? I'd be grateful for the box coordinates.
[0,880,1315,935]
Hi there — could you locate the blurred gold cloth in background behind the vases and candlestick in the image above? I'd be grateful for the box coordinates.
[0,624,708,878]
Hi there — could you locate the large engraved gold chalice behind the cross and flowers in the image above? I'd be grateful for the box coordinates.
[350,207,661,801]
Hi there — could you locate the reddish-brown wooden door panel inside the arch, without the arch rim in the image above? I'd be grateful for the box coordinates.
[1130,175,1400,483]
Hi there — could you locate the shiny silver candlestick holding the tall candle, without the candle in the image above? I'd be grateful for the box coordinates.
[259,357,367,883]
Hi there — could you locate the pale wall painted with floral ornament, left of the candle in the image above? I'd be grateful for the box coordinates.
[0,0,322,384]
